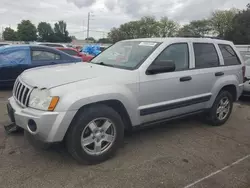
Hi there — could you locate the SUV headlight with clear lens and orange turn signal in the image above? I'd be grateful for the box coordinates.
[29,89,59,111]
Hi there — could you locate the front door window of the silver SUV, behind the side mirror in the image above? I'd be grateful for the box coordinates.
[155,43,189,71]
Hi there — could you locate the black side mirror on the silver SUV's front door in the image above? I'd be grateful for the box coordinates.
[146,60,175,75]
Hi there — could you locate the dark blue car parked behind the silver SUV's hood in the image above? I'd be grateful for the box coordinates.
[0,45,82,88]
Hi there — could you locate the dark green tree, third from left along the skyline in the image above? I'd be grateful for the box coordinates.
[37,22,54,42]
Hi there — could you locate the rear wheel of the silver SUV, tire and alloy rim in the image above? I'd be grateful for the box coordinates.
[208,91,233,126]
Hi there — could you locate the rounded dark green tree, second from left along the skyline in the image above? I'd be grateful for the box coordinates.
[17,20,37,41]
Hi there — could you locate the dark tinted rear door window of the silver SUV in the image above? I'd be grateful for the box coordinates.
[194,43,220,69]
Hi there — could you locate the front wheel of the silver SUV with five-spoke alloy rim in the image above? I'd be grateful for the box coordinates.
[66,104,124,164]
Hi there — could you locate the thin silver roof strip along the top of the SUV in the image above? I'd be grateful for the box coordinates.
[125,37,232,44]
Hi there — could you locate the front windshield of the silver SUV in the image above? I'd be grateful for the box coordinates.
[91,41,159,69]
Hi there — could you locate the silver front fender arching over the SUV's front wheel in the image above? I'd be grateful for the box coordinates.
[56,85,140,125]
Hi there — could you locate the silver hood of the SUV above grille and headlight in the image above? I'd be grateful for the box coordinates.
[20,63,126,89]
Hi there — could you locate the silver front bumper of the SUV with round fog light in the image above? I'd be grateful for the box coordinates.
[8,97,76,143]
